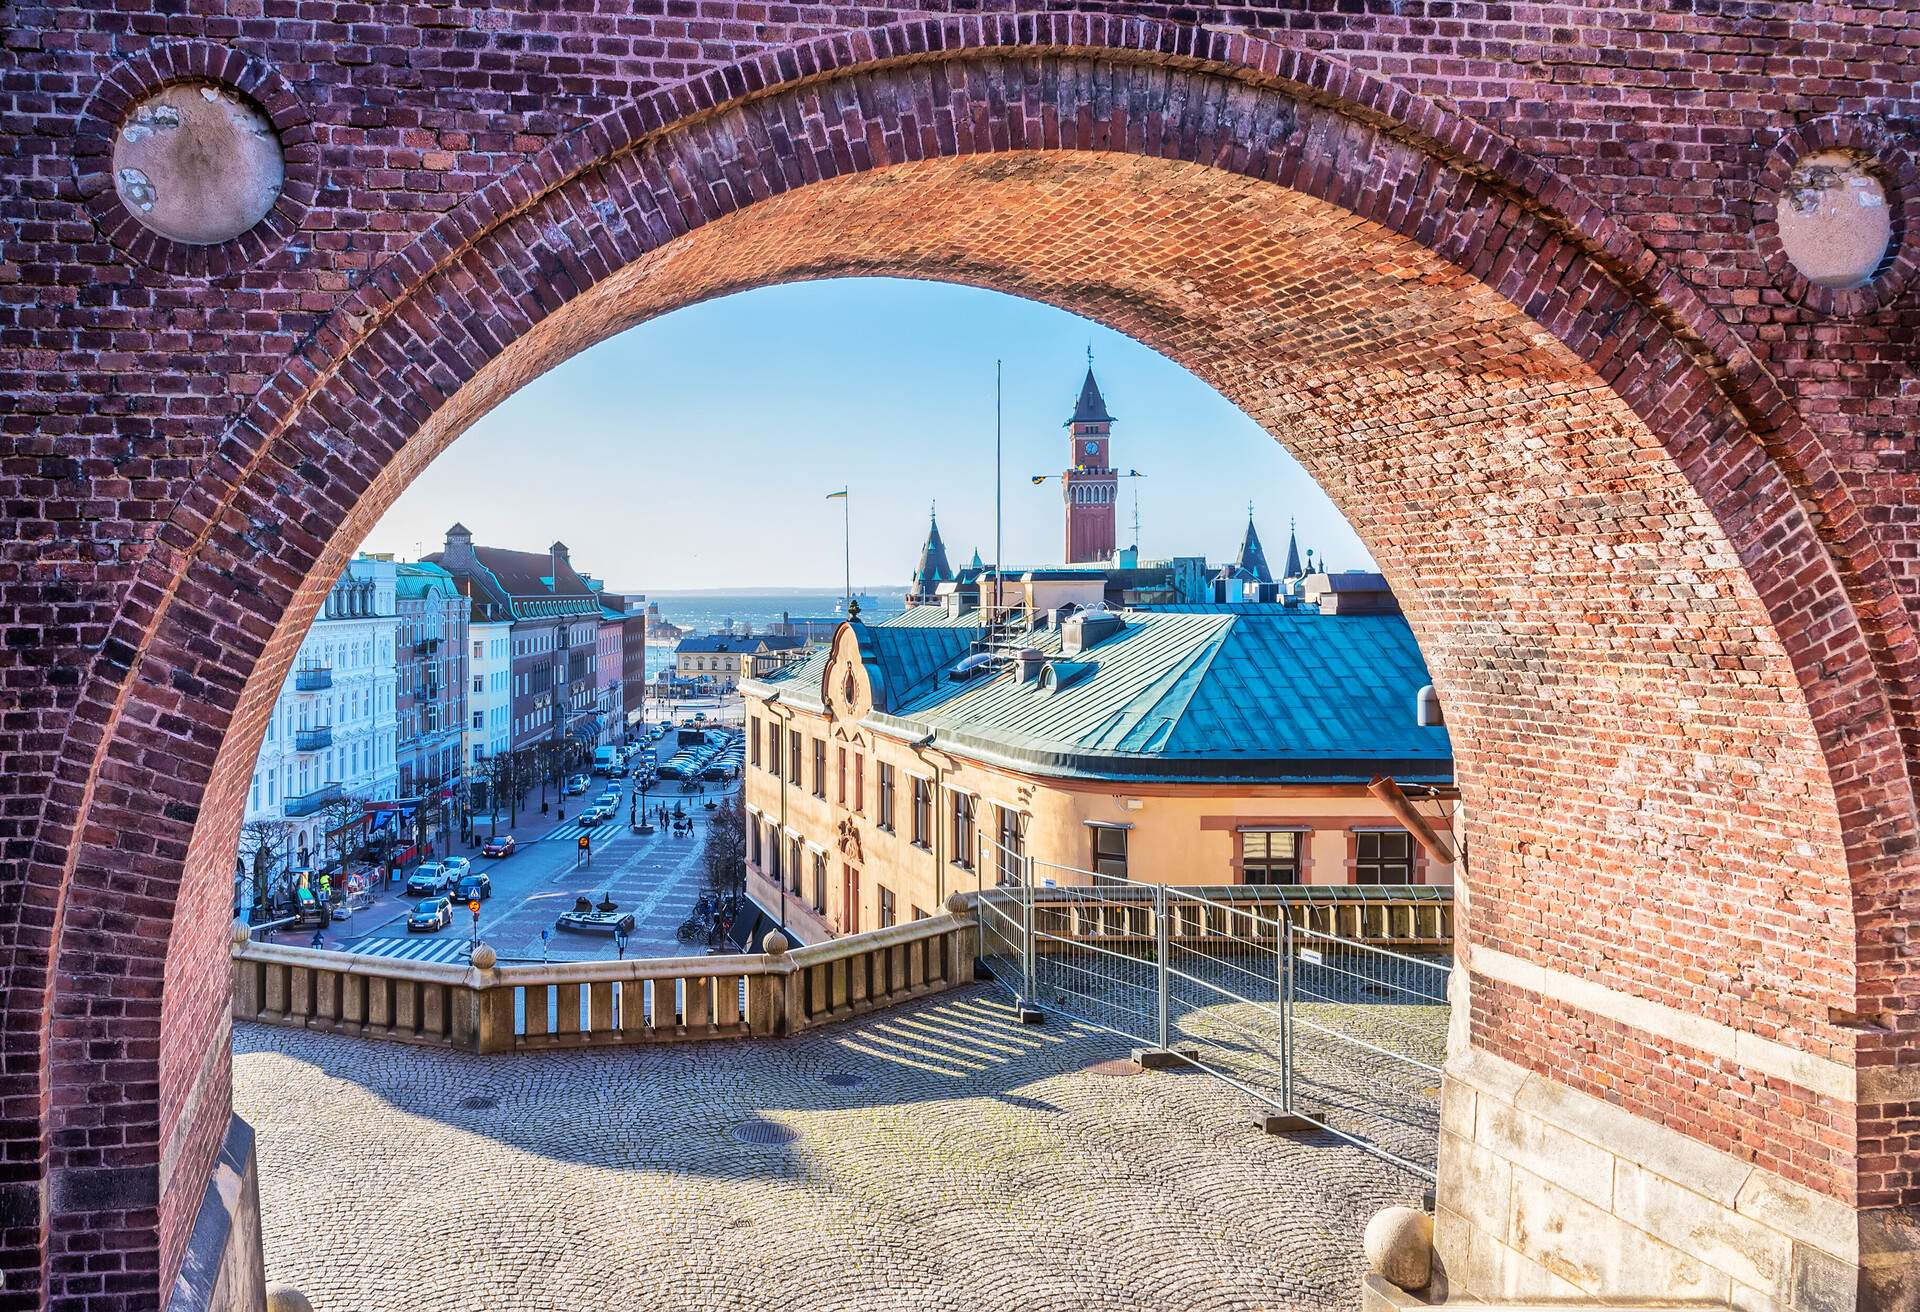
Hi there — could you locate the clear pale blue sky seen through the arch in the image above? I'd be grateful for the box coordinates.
[365,279,1369,592]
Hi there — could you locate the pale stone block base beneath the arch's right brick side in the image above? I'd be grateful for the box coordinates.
[1428,1049,1920,1312]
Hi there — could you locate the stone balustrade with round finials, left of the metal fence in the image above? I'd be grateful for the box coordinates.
[232,895,975,1053]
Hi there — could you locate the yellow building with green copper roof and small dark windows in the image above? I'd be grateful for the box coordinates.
[741,607,1455,941]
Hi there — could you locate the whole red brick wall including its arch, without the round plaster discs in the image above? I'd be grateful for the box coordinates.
[0,0,1920,1308]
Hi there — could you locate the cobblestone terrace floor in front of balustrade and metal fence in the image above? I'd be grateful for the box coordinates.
[234,985,1421,1312]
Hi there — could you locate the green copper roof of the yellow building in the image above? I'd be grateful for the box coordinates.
[741,603,1453,784]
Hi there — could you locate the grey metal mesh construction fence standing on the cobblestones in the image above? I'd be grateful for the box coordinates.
[977,855,1452,1179]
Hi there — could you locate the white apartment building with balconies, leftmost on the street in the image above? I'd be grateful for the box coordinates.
[242,559,399,866]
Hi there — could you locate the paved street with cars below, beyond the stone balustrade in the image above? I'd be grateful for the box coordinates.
[291,718,739,962]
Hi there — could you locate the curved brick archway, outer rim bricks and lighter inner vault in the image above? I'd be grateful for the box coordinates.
[10,15,1914,1299]
